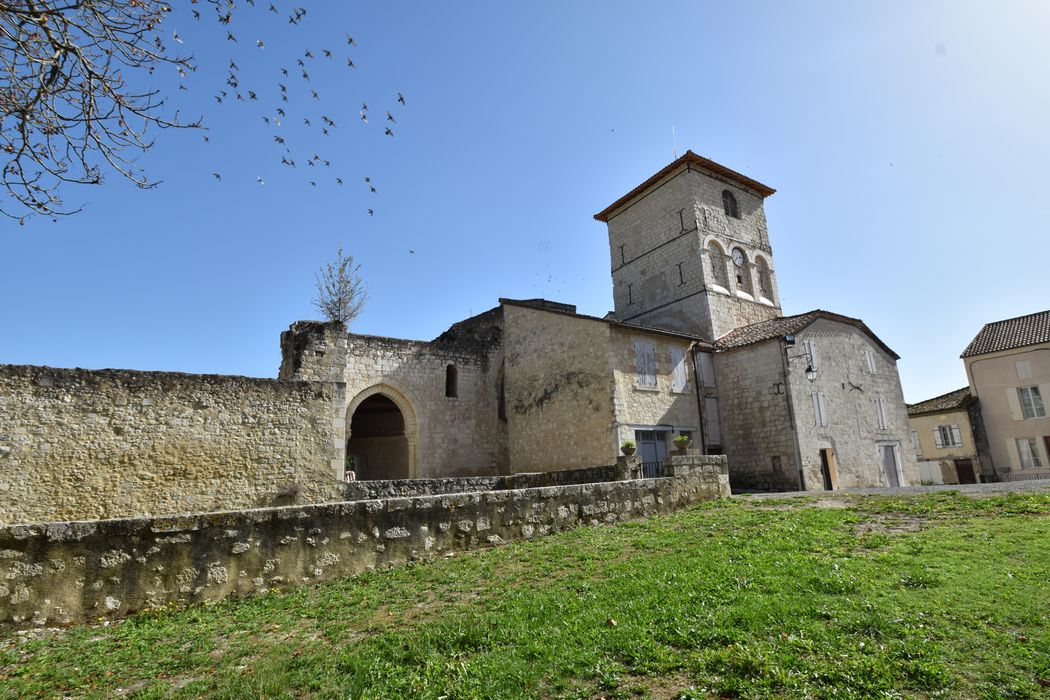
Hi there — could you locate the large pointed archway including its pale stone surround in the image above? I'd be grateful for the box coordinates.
[347,386,416,481]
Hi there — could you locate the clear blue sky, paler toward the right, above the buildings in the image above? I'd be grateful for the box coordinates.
[0,0,1050,402]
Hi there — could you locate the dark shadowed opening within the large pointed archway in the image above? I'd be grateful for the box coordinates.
[347,394,410,480]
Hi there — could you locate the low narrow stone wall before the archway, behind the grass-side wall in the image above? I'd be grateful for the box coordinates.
[344,465,617,501]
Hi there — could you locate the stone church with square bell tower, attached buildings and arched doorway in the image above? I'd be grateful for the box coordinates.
[279,151,919,490]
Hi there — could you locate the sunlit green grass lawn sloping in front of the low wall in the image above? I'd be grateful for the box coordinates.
[0,492,1050,699]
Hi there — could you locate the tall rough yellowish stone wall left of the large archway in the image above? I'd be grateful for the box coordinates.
[0,365,344,523]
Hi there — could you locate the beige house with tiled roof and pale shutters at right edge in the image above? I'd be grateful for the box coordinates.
[962,311,1050,480]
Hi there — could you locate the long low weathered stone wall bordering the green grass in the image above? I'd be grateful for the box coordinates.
[0,457,729,627]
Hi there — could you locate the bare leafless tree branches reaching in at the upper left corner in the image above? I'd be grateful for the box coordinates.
[0,0,199,219]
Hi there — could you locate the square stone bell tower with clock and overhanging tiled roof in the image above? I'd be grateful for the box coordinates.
[594,151,781,340]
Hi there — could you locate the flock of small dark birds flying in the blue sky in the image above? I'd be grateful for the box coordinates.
[170,0,406,216]
